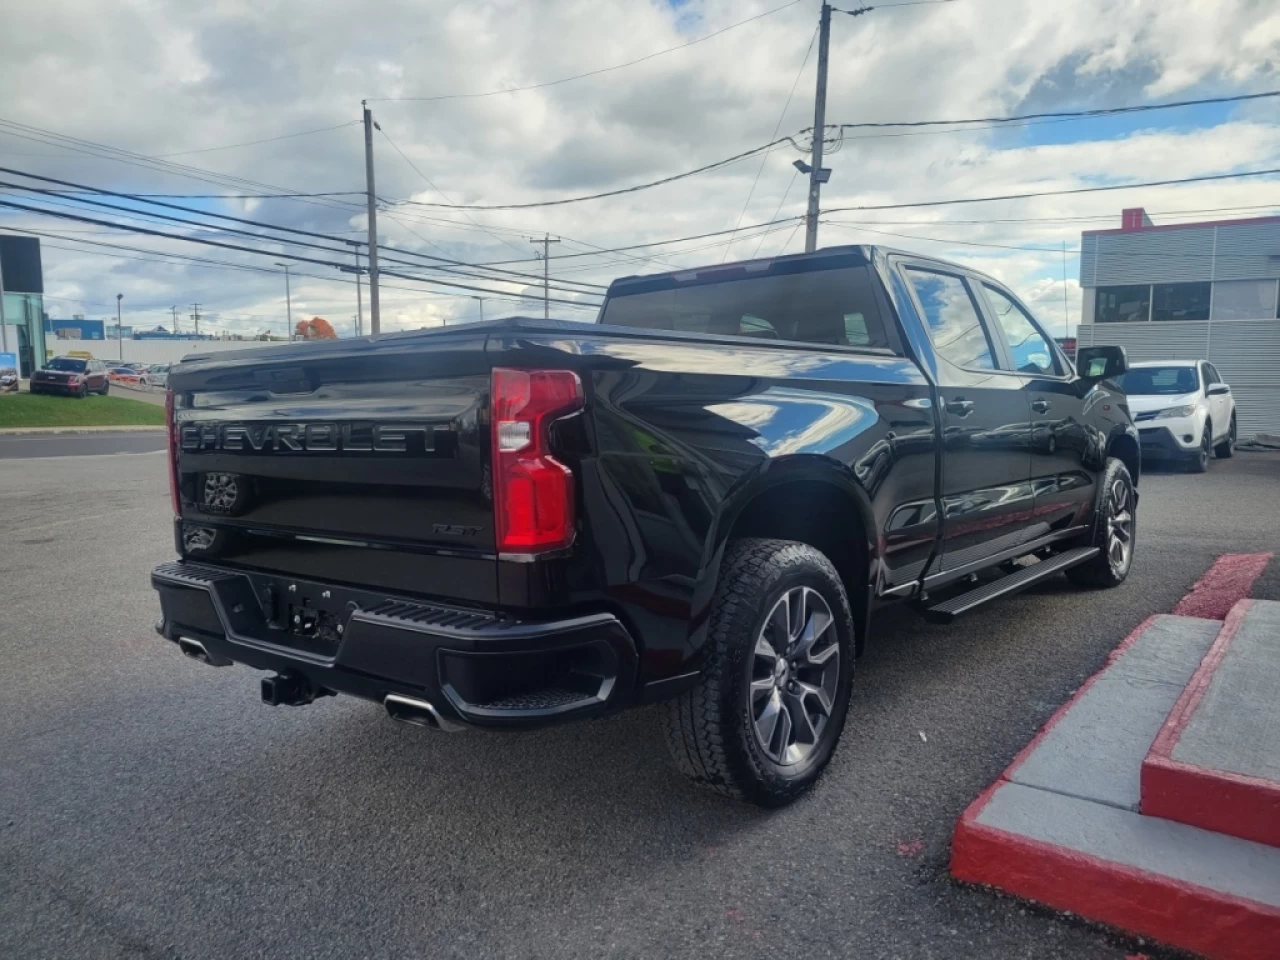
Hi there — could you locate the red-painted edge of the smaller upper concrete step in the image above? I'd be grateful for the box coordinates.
[1139,600,1280,846]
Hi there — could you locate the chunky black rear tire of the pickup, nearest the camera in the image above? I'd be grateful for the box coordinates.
[667,539,854,806]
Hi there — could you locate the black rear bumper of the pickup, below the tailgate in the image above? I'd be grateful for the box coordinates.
[151,563,636,730]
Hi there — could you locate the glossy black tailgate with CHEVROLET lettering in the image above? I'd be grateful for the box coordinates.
[170,332,495,602]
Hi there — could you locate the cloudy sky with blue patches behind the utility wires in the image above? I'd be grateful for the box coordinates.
[0,0,1280,332]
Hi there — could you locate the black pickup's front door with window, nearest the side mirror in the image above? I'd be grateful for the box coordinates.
[978,280,1096,529]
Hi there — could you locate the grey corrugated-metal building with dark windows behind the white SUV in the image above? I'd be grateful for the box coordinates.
[1076,209,1280,439]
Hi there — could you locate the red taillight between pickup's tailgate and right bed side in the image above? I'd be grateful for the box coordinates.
[492,367,582,553]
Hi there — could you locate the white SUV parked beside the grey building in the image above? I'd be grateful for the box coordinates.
[1117,360,1235,474]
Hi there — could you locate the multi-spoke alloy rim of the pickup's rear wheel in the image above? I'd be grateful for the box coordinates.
[748,586,840,767]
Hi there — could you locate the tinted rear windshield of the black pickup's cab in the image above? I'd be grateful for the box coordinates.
[600,266,890,348]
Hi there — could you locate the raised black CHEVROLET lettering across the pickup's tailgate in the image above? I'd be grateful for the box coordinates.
[180,420,436,454]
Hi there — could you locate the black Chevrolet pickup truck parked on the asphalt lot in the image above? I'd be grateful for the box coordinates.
[151,247,1140,805]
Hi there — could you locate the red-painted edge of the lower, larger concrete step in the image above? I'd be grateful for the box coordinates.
[951,614,1280,960]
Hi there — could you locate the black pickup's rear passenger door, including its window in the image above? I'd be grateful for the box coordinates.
[897,260,1043,573]
